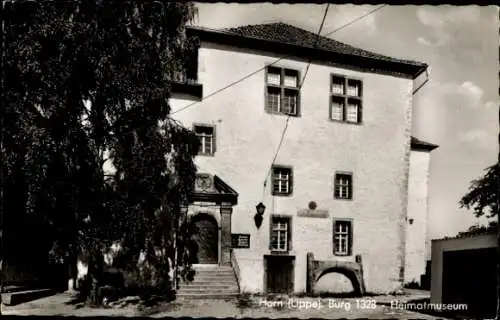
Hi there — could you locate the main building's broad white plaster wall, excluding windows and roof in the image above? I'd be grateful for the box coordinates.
[171,43,412,292]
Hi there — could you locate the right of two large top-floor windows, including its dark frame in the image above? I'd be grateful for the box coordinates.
[330,75,363,124]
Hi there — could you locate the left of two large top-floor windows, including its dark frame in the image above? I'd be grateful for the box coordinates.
[266,67,300,117]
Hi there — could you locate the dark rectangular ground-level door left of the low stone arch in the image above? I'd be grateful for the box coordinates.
[265,256,295,293]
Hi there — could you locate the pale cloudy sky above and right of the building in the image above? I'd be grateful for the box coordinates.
[195,3,500,239]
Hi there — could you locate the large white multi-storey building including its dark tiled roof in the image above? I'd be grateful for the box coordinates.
[170,23,436,293]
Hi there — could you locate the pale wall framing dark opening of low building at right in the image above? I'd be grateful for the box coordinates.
[431,234,498,303]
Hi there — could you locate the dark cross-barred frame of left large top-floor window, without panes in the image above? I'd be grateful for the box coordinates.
[264,65,301,117]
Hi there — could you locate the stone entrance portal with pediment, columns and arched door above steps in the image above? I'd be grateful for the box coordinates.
[183,173,238,264]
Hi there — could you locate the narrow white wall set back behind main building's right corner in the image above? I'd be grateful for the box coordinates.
[405,150,430,283]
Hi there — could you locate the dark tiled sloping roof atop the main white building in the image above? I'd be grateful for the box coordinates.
[186,22,428,78]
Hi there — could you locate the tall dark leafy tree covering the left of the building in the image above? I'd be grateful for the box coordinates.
[1,0,198,304]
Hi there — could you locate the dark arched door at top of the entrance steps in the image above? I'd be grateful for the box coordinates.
[190,213,219,264]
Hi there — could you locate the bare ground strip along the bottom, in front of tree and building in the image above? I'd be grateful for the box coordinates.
[2,293,442,319]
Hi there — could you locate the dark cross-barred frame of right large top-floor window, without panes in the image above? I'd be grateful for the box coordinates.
[328,73,364,125]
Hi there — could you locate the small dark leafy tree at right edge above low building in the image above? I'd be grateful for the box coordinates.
[460,162,500,319]
